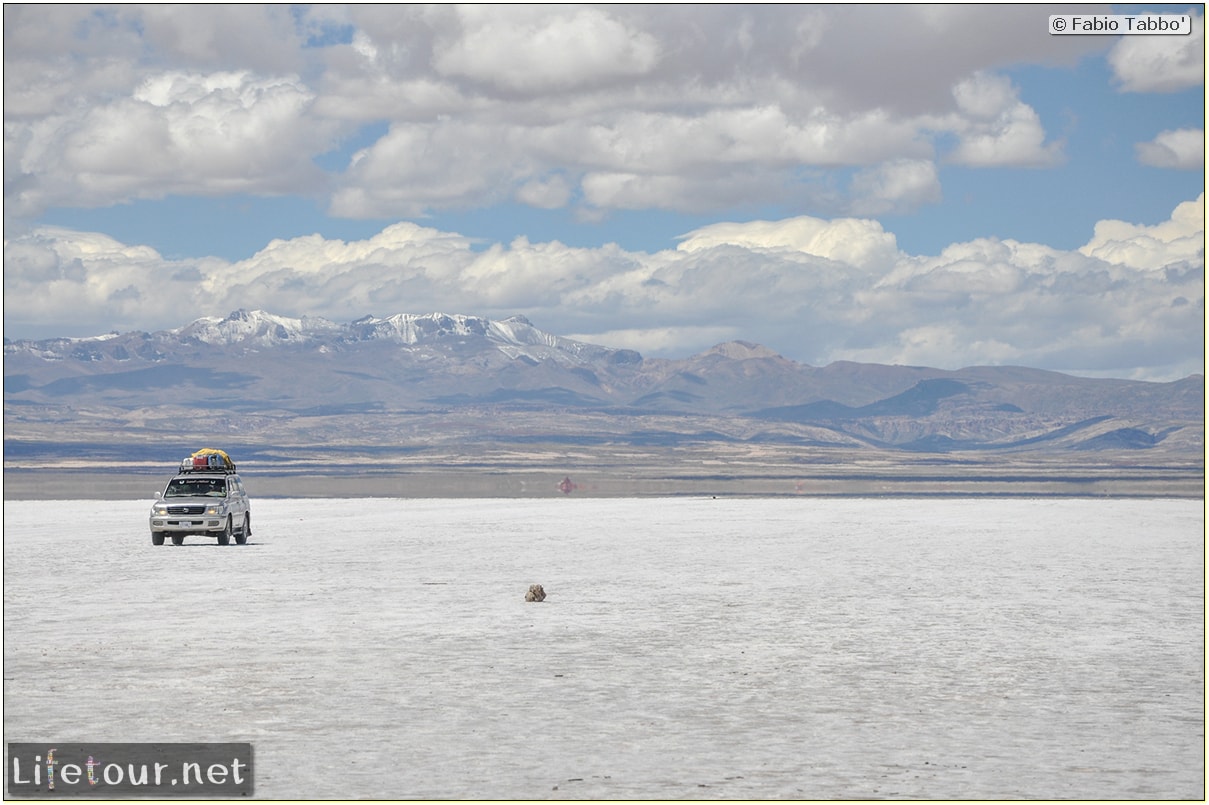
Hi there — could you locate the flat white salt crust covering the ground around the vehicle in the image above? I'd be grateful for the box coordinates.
[4,497,1205,799]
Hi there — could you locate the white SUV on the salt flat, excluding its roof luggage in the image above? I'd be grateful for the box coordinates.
[150,467,251,545]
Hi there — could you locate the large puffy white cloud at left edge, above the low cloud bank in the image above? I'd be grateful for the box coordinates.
[5,71,334,214]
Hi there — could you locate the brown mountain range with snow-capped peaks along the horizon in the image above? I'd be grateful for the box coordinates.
[5,311,1204,457]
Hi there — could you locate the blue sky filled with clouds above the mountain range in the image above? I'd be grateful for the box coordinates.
[5,5,1204,380]
